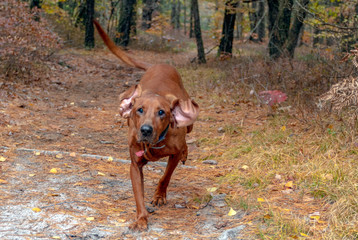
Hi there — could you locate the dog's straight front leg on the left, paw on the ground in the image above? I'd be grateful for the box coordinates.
[129,152,149,231]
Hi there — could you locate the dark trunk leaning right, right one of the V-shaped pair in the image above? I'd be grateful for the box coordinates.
[286,0,309,58]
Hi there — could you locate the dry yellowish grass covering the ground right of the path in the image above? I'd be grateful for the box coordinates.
[180,44,358,239]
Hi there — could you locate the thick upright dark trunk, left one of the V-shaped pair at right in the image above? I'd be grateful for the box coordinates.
[267,0,293,59]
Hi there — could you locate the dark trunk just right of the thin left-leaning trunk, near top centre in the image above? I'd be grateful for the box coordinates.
[218,0,238,56]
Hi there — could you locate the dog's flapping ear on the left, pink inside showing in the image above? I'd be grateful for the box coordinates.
[119,85,142,118]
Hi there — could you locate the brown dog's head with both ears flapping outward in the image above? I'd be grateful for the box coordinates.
[119,85,199,144]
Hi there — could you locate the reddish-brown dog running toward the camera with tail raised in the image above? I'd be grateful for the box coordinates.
[94,21,199,230]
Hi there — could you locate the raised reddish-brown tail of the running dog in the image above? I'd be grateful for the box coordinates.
[93,20,150,70]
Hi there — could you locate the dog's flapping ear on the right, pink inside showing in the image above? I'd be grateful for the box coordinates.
[167,95,199,127]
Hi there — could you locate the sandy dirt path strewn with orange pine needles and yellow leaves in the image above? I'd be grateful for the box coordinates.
[0,49,245,239]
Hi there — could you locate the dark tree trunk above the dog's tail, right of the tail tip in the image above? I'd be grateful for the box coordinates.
[115,0,136,47]
